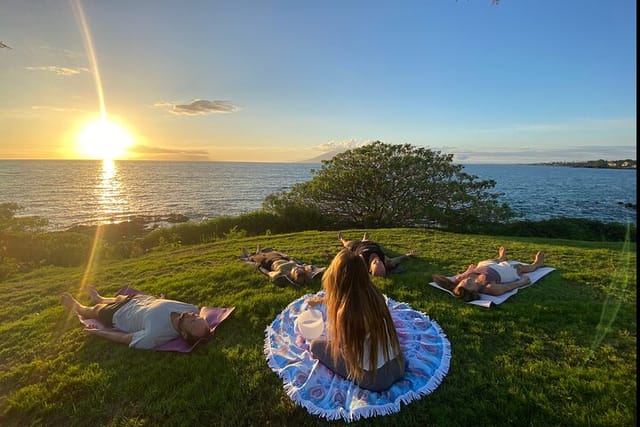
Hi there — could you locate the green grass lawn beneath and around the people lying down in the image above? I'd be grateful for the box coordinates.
[0,229,637,426]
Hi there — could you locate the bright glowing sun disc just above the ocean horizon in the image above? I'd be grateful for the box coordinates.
[76,119,134,160]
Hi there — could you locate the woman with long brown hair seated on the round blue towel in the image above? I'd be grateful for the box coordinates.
[307,249,405,391]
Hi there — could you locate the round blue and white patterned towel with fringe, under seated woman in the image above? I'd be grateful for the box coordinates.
[264,291,451,422]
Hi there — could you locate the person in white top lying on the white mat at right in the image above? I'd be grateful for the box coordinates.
[433,246,544,302]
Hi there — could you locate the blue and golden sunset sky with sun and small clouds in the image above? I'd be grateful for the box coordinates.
[0,0,637,164]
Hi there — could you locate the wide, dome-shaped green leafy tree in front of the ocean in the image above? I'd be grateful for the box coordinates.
[264,141,511,229]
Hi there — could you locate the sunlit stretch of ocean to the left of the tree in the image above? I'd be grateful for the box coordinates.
[0,160,318,229]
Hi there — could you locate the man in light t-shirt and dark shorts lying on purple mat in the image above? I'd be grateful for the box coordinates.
[62,287,211,349]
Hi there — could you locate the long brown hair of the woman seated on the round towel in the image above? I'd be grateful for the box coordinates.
[322,249,403,381]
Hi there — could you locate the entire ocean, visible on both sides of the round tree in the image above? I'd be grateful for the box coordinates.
[0,160,636,230]
